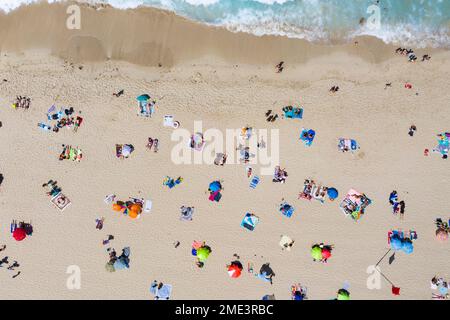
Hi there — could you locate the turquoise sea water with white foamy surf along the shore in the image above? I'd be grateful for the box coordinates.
[0,0,450,48]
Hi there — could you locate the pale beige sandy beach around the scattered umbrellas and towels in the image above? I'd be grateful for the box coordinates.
[0,4,450,300]
